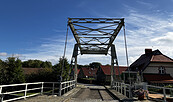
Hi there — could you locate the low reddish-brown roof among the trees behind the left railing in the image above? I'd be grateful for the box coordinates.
[22,68,44,74]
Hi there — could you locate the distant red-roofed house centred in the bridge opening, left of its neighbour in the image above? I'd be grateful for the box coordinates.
[78,67,98,79]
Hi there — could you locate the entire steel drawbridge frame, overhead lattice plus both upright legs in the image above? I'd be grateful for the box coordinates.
[68,18,124,86]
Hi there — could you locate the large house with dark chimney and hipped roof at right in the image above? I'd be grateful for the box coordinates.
[129,49,173,83]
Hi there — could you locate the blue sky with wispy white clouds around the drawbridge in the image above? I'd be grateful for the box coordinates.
[0,0,173,65]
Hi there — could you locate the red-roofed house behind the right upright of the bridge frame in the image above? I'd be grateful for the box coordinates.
[97,65,128,83]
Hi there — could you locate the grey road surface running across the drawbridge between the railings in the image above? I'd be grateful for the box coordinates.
[14,84,153,102]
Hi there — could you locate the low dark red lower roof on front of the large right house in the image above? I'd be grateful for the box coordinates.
[144,74,173,83]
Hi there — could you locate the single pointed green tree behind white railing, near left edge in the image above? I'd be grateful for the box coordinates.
[6,57,25,84]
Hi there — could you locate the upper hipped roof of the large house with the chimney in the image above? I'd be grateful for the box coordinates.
[130,50,173,71]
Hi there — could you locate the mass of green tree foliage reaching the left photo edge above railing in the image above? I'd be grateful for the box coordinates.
[0,57,25,84]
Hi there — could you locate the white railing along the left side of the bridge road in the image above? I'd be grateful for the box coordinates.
[0,80,75,102]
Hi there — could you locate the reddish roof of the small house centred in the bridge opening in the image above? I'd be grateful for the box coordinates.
[81,67,98,76]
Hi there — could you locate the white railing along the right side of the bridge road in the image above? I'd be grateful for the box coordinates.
[113,82,173,102]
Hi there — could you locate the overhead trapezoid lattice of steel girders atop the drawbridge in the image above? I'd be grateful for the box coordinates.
[68,18,124,55]
